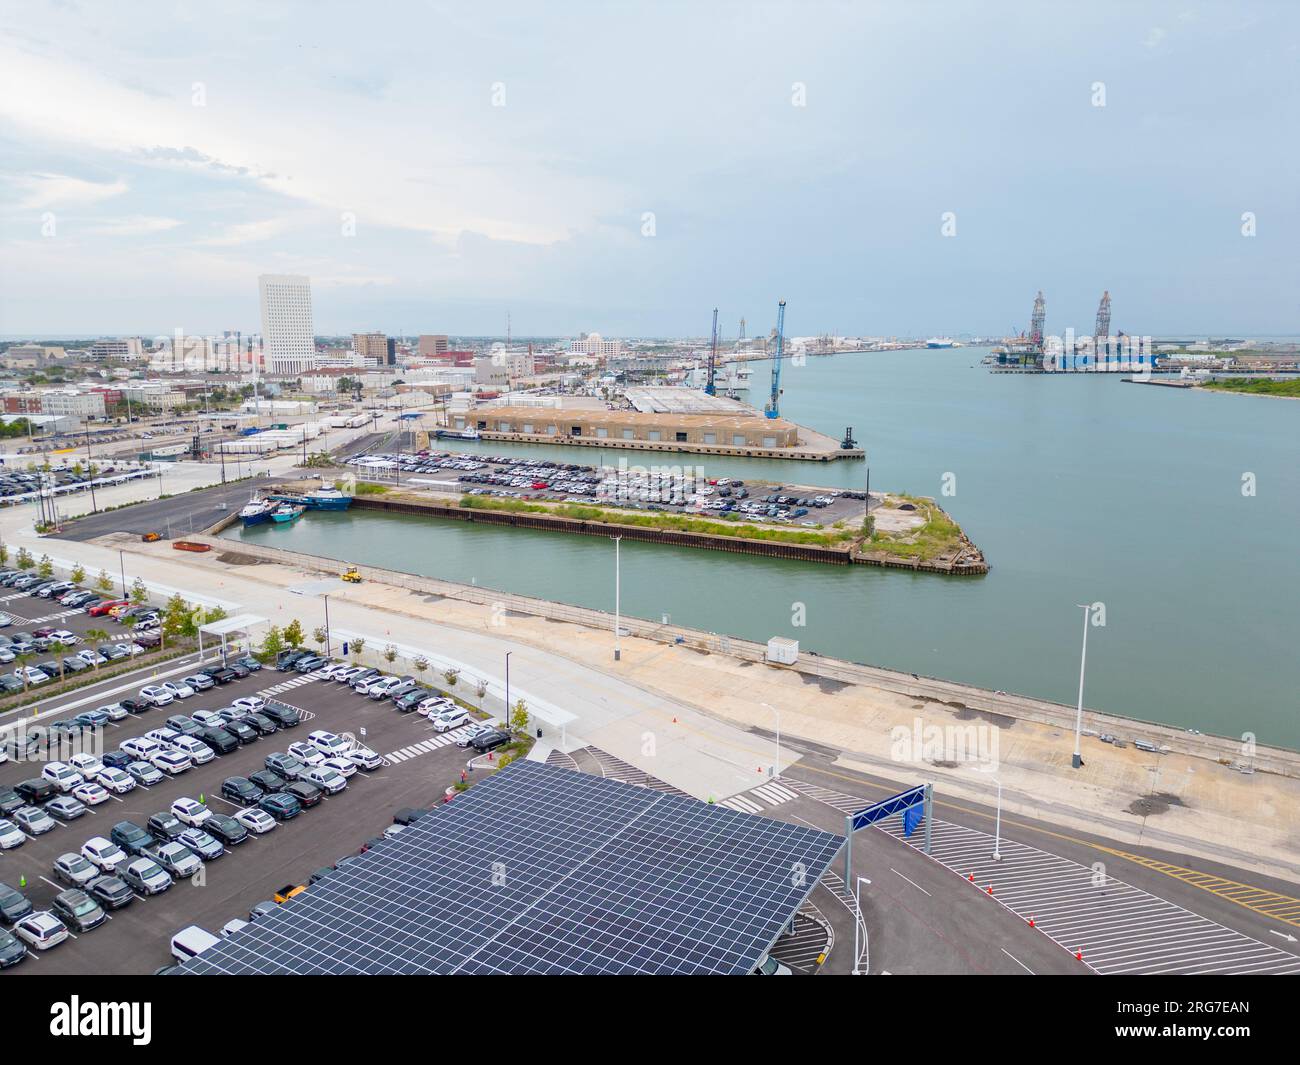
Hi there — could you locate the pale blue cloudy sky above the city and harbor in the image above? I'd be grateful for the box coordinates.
[0,0,1300,338]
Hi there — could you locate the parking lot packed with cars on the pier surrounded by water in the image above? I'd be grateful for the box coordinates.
[347,451,866,528]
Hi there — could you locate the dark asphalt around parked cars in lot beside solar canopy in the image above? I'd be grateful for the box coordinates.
[0,657,488,974]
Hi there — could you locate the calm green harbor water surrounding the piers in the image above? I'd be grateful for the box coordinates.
[230,348,1300,746]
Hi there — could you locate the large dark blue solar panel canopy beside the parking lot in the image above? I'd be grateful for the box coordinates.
[181,761,842,974]
